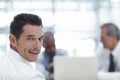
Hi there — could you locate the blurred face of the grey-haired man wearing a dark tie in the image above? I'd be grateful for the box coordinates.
[101,27,113,49]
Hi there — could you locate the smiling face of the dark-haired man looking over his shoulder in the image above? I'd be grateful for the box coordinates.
[11,24,43,62]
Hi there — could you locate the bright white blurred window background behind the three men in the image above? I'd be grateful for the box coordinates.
[0,0,120,56]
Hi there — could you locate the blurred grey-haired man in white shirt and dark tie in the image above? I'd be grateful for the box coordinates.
[97,23,120,72]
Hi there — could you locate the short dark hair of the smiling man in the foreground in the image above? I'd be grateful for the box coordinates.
[10,13,42,39]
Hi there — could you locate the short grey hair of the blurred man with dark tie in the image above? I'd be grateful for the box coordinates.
[101,23,120,40]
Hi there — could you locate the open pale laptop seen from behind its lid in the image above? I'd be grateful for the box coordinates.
[54,56,97,80]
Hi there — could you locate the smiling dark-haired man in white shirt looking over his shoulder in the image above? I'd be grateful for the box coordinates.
[0,13,45,80]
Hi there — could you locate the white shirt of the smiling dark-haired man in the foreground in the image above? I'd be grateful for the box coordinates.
[0,49,45,80]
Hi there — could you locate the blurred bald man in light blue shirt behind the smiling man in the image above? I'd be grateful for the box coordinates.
[36,31,67,80]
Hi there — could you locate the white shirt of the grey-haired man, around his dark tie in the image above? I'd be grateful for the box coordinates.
[97,41,120,72]
